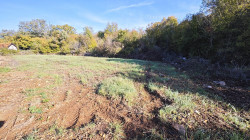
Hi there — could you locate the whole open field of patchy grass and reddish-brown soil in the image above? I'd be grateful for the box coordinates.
[0,55,250,140]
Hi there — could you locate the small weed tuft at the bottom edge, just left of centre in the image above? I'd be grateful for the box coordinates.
[109,123,125,140]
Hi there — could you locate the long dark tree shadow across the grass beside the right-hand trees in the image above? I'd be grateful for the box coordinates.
[107,58,250,111]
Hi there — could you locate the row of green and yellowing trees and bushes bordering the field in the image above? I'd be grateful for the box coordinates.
[0,0,250,65]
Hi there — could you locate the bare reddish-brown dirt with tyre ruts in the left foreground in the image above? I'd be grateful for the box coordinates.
[0,68,180,139]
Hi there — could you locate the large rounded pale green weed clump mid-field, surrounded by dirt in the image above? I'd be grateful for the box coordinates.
[97,77,138,104]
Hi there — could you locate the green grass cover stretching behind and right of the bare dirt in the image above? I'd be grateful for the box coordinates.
[1,55,249,139]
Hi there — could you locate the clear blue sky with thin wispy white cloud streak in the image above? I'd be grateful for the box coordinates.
[0,0,202,33]
